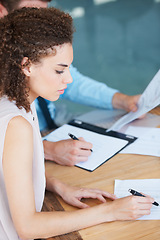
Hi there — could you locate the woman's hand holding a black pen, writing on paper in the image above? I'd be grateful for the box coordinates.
[107,196,154,221]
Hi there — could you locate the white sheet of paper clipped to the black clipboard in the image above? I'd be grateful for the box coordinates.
[45,124,128,171]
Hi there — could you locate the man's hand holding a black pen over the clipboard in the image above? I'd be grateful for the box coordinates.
[43,138,92,166]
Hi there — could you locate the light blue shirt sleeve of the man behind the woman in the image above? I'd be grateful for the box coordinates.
[61,65,118,109]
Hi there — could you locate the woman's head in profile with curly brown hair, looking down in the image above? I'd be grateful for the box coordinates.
[0,8,74,112]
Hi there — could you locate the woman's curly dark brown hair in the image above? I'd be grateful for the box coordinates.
[0,8,74,112]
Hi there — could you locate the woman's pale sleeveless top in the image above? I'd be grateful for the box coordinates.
[0,97,45,240]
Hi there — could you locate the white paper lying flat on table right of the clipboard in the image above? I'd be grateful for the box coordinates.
[120,127,160,157]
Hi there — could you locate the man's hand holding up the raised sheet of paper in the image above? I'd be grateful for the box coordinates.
[112,93,141,112]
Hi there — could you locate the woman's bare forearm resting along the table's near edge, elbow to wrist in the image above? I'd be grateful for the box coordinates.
[17,204,112,239]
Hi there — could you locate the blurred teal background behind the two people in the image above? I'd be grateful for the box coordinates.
[50,0,160,115]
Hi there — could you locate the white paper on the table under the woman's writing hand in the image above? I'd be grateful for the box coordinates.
[114,179,160,220]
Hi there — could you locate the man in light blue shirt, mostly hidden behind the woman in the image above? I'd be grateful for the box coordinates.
[0,0,139,166]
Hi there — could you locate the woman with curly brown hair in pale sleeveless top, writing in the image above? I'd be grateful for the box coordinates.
[0,8,153,240]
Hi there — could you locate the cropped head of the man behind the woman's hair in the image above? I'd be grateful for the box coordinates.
[0,0,51,18]
